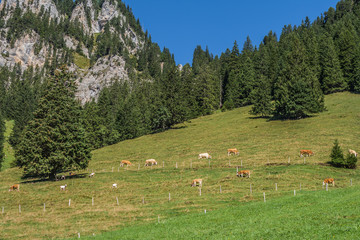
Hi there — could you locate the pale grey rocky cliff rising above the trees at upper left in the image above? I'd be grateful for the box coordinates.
[0,0,143,103]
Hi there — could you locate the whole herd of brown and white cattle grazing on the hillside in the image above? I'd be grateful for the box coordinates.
[9,148,357,191]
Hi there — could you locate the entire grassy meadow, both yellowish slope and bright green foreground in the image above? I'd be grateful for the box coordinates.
[0,93,360,239]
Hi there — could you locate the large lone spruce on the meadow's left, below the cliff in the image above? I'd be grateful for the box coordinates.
[15,68,91,178]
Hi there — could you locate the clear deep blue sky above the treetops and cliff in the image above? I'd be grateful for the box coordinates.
[123,0,339,65]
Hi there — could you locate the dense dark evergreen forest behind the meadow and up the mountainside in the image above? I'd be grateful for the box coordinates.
[0,0,360,171]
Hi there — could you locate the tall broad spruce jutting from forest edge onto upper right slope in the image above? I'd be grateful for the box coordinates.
[274,33,324,119]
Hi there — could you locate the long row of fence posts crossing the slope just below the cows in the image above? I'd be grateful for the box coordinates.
[0,179,354,216]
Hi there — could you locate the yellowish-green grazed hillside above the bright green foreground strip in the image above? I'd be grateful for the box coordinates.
[0,93,360,239]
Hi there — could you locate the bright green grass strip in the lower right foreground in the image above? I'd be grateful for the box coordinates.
[74,187,360,239]
